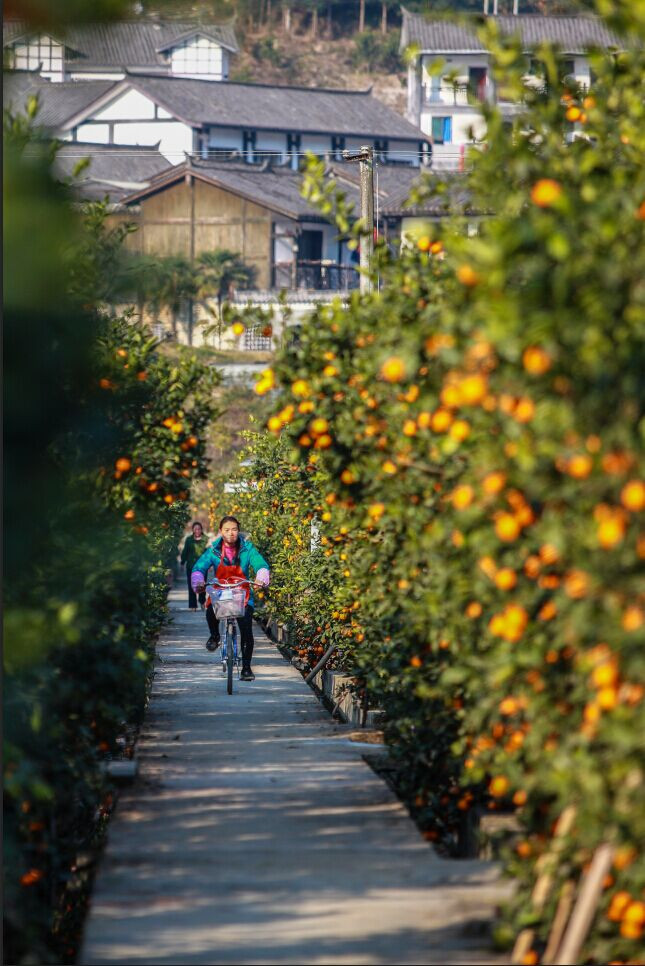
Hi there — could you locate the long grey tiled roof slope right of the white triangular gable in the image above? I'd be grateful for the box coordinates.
[128,74,424,142]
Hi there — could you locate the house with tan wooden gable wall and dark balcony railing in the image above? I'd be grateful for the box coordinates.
[121,151,445,348]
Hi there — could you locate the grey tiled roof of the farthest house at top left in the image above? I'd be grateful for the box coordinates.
[2,20,238,71]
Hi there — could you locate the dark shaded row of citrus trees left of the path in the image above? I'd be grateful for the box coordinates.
[4,105,220,963]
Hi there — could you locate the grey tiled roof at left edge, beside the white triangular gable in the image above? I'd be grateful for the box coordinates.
[3,70,115,130]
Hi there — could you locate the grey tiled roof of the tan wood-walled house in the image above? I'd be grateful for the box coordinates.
[126,159,359,220]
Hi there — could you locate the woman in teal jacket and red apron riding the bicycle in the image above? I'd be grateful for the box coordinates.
[192,516,271,681]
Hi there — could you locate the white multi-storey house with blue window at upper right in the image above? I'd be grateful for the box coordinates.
[401,7,622,169]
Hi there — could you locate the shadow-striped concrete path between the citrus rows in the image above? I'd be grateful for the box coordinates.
[79,590,508,966]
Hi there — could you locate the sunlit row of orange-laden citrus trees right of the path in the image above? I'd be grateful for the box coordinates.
[220,7,645,963]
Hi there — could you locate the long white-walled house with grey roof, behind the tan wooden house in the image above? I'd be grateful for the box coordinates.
[5,71,429,168]
